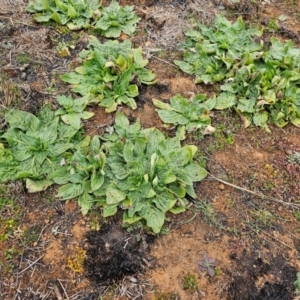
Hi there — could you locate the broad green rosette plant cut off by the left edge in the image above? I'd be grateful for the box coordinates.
[0,105,78,192]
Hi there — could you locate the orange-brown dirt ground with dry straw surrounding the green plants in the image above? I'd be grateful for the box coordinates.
[0,0,300,300]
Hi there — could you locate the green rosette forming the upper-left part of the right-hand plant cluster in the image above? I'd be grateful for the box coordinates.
[175,15,263,84]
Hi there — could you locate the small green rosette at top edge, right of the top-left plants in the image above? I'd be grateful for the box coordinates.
[95,0,141,38]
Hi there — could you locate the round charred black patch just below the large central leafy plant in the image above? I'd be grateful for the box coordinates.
[85,224,151,285]
